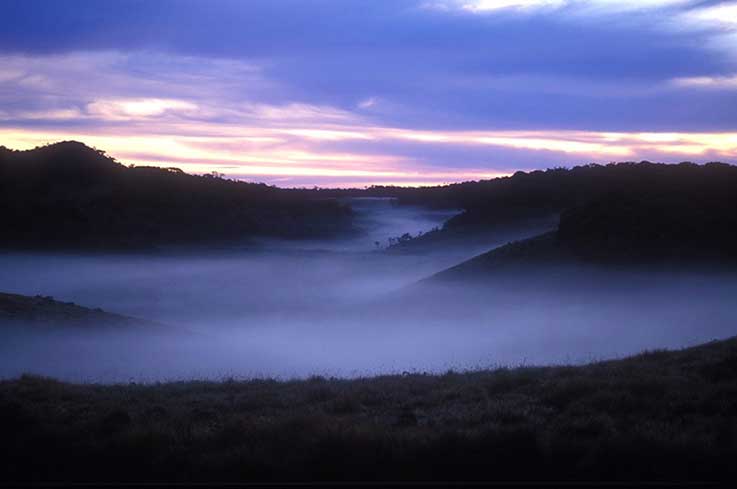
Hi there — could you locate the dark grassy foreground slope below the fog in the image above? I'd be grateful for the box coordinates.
[0,339,737,483]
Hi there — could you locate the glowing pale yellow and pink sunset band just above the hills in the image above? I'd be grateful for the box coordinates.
[0,124,737,187]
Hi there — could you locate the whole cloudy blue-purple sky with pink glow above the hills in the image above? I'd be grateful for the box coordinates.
[0,0,737,187]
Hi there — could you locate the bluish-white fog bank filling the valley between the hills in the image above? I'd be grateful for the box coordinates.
[0,200,737,382]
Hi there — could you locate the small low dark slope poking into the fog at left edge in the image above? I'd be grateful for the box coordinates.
[0,292,165,330]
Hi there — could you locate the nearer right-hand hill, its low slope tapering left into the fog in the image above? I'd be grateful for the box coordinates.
[433,189,737,280]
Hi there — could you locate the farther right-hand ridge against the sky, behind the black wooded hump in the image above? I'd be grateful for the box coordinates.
[386,162,737,251]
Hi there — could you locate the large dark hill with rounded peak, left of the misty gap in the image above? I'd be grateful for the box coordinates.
[0,141,351,248]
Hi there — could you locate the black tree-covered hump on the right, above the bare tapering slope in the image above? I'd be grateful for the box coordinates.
[558,189,737,263]
